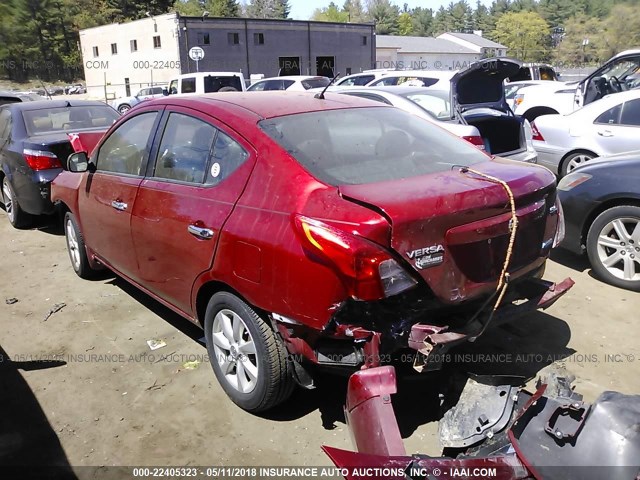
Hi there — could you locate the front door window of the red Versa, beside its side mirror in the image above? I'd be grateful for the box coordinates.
[96,112,158,175]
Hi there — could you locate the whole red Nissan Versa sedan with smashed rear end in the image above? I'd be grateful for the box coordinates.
[52,92,572,411]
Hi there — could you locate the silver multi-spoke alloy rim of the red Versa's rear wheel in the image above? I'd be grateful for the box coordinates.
[212,309,260,393]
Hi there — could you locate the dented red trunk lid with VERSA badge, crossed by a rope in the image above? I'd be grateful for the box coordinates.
[339,159,557,303]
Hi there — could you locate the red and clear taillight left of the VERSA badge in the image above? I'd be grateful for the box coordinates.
[294,215,416,300]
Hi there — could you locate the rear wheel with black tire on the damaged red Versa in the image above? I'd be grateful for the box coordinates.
[204,292,295,412]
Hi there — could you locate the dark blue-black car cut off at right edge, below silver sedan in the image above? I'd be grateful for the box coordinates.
[558,151,640,291]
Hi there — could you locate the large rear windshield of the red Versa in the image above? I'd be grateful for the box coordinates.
[260,107,487,186]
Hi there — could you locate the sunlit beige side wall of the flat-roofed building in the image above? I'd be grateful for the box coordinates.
[80,13,181,100]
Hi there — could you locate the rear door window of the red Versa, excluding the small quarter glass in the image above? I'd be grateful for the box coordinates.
[154,113,216,183]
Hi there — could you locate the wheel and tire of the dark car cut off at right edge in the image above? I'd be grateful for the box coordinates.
[587,205,640,292]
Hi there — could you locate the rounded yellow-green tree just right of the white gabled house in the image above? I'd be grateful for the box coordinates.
[493,12,550,62]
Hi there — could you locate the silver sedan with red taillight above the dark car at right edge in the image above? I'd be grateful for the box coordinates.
[533,90,640,177]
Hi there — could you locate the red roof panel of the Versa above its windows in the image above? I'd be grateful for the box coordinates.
[145,90,383,119]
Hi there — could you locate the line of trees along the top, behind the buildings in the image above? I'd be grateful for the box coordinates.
[0,0,640,81]
